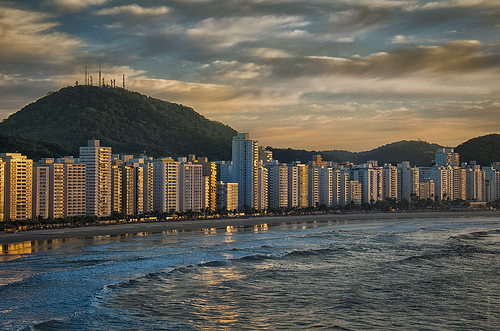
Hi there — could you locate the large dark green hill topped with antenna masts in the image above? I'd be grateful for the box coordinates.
[0,85,236,160]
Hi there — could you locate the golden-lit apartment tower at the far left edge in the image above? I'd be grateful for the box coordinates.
[0,153,33,221]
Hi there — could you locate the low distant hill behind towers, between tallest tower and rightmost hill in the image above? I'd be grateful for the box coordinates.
[268,140,441,166]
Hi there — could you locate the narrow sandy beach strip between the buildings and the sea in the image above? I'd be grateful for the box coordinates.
[0,211,500,245]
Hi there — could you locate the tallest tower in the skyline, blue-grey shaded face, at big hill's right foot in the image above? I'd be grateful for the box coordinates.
[232,133,259,210]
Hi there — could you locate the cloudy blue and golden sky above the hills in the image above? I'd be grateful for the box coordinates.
[0,0,500,151]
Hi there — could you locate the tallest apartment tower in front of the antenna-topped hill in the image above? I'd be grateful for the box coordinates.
[80,140,111,217]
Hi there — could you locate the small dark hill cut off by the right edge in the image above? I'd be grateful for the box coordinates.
[455,133,500,166]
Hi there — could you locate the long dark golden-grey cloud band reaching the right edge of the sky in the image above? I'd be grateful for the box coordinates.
[273,40,500,79]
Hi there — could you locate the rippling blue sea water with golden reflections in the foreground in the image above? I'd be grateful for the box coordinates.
[0,217,500,330]
